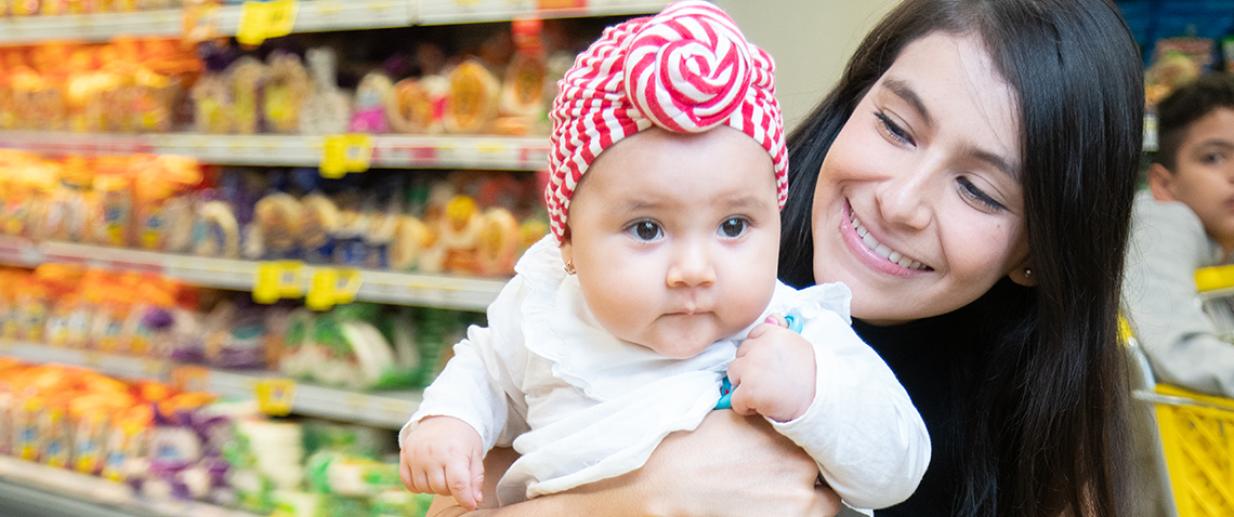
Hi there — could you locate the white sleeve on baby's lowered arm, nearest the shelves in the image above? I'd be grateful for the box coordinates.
[399,276,527,450]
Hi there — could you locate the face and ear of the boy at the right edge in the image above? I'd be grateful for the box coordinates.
[1149,107,1234,255]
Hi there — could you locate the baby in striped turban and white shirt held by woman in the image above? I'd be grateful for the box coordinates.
[400,0,930,510]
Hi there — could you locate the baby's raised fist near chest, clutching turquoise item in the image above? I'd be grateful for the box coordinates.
[728,317,817,422]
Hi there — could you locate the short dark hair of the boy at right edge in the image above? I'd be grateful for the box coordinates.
[1154,73,1234,174]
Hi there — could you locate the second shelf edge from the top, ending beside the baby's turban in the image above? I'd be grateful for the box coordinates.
[0,131,548,170]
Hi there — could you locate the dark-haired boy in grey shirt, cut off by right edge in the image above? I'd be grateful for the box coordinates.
[1123,73,1234,397]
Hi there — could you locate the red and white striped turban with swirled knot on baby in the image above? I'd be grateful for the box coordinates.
[544,0,789,242]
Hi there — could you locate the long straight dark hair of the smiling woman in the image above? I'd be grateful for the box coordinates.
[780,0,1144,516]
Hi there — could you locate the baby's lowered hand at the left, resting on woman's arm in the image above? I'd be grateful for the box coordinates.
[399,417,484,511]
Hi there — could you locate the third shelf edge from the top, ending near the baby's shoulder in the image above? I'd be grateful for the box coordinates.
[0,236,506,311]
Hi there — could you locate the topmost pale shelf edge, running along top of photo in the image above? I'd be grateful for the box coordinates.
[0,0,670,44]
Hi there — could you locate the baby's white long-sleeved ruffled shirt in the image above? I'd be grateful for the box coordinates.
[399,236,930,508]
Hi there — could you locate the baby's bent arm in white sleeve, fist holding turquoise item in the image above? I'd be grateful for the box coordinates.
[729,312,930,508]
